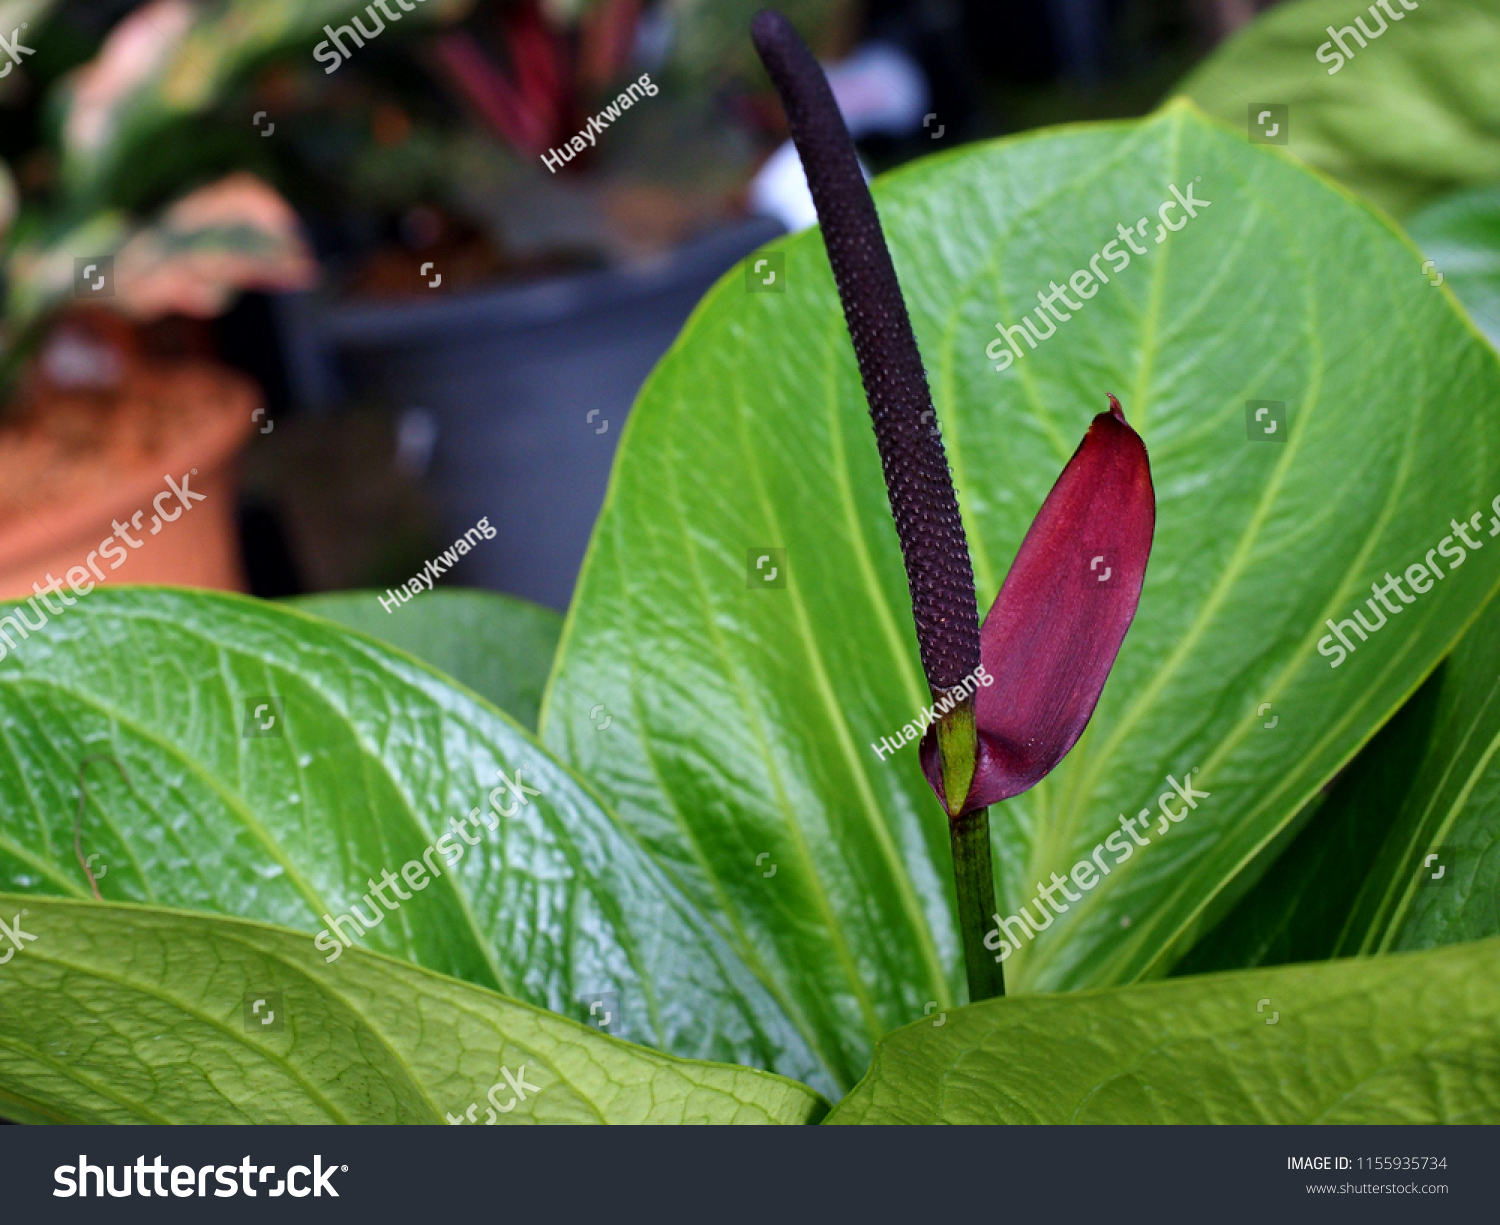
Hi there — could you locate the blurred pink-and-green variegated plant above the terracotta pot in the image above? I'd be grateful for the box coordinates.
[0,0,471,402]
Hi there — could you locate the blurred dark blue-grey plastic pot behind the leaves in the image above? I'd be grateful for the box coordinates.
[278,219,783,609]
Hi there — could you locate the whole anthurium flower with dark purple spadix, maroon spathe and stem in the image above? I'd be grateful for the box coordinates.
[750,9,1157,1000]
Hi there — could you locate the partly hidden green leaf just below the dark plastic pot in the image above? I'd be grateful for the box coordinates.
[291,588,563,729]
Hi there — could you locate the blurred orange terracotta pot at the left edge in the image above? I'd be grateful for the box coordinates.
[0,364,260,600]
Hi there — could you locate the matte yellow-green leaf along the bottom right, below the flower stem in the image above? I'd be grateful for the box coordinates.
[827,940,1500,1123]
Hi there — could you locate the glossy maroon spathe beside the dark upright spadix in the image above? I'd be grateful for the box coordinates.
[921,396,1157,816]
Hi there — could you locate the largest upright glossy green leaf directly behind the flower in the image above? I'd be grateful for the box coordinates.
[542,105,1500,1084]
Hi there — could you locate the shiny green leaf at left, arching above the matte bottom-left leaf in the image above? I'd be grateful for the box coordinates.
[0,584,830,1084]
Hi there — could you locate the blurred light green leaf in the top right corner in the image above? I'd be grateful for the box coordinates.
[1178,0,1500,216]
